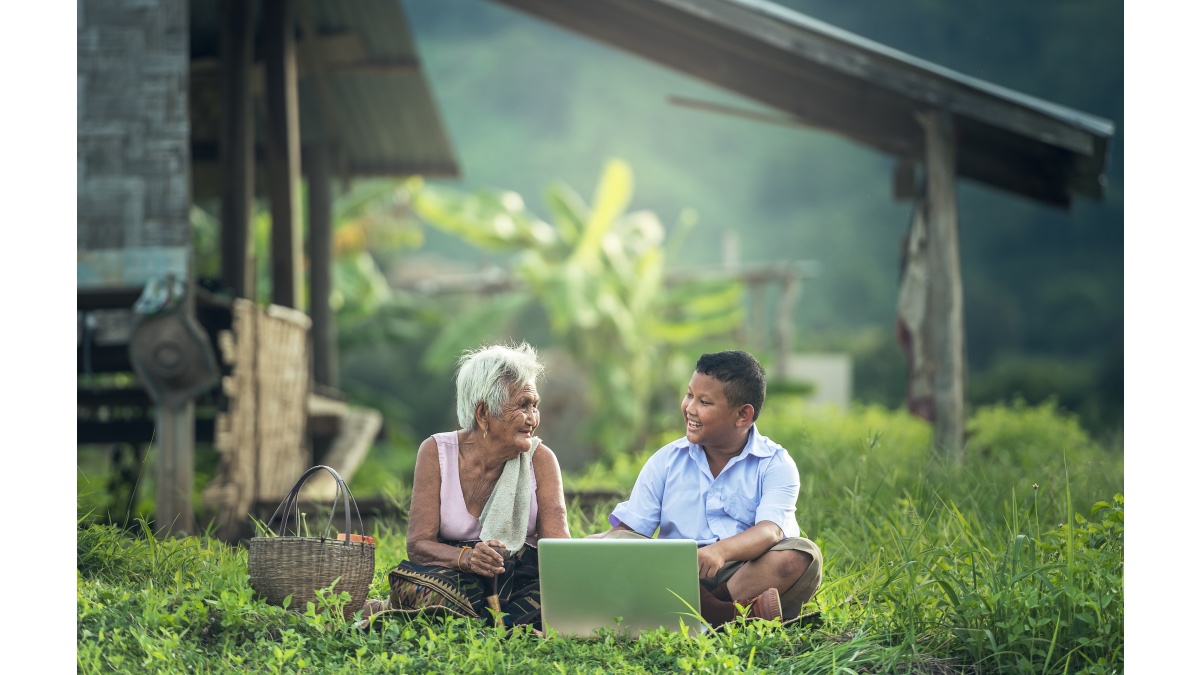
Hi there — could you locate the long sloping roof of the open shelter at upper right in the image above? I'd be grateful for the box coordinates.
[494,0,1114,207]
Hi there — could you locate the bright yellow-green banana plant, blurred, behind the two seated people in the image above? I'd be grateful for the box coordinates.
[408,160,744,454]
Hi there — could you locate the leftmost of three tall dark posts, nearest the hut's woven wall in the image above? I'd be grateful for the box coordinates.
[221,0,254,298]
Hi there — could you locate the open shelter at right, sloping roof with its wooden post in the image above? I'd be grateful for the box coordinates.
[494,0,1114,454]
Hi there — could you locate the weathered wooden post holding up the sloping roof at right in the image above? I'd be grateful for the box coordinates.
[918,110,965,459]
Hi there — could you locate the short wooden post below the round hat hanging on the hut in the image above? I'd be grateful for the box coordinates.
[154,400,196,538]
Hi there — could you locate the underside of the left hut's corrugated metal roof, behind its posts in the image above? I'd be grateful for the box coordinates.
[190,0,458,195]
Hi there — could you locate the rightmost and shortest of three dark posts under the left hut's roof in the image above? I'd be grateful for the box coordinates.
[305,147,337,389]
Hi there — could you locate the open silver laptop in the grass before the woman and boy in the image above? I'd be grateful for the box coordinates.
[538,539,702,638]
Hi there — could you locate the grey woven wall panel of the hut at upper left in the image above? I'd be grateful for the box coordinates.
[76,0,191,251]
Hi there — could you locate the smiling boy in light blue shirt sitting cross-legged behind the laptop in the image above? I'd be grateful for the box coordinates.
[590,351,822,628]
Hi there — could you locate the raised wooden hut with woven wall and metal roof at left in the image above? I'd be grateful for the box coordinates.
[77,0,458,532]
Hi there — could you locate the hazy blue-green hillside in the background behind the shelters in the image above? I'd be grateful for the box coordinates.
[404,0,1124,432]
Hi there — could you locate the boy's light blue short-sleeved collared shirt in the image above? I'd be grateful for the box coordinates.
[608,425,800,545]
